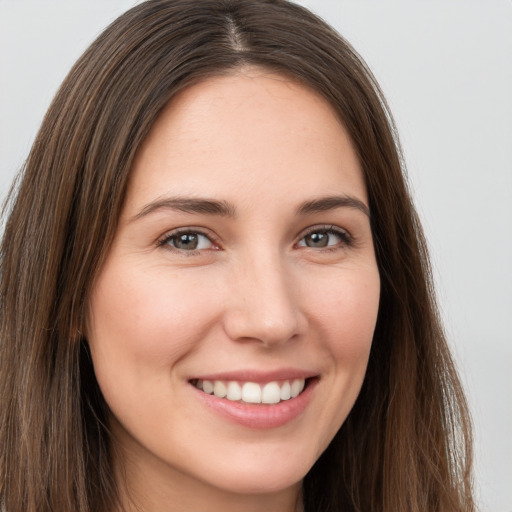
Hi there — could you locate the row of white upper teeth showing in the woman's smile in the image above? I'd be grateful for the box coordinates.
[196,379,305,404]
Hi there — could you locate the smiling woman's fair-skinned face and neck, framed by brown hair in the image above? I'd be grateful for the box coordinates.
[87,68,380,512]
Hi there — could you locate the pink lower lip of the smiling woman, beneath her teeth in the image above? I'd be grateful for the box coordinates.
[191,378,318,429]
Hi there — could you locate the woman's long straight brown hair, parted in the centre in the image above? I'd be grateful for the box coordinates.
[0,0,474,512]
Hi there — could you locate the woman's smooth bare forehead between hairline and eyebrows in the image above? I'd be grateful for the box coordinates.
[127,68,366,212]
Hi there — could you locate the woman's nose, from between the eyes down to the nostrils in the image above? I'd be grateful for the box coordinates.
[224,256,306,347]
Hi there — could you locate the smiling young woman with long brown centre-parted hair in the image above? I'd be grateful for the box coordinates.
[0,0,474,512]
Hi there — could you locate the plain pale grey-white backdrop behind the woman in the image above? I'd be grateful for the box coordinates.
[0,0,512,512]
